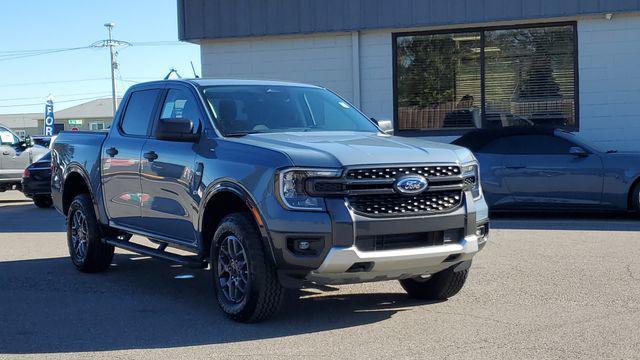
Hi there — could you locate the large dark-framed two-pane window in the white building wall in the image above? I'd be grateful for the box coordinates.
[394,24,578,133]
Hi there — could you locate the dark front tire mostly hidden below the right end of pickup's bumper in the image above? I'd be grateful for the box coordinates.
[400,266,469,300]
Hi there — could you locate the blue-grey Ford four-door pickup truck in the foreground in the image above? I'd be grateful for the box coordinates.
[51,79,489,322]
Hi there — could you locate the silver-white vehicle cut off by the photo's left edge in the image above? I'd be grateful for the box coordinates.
[0,125,49,192]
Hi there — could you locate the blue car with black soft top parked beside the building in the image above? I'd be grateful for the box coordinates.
[453,126,640,211]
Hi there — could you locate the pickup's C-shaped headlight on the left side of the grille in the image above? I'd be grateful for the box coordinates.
[276,168,341,211]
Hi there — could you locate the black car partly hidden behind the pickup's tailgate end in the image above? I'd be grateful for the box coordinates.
[22,152,53,208]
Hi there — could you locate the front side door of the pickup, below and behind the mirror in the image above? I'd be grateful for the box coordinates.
[141,84,204,245]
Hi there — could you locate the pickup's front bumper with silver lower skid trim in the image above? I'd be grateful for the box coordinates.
[270,193,489,287]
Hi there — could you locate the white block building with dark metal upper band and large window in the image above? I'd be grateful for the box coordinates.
[178,0,640,150]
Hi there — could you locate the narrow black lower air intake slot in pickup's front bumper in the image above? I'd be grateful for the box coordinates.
[356,229,464,251]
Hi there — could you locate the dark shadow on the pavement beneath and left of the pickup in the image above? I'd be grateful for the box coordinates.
[0,255,421,354]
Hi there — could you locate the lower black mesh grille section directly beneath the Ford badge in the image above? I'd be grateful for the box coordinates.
[348,191,462,216]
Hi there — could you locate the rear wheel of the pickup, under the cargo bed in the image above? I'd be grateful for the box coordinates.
[67,194,114,273]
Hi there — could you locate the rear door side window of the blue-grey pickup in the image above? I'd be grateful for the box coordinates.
[120,89,160,135]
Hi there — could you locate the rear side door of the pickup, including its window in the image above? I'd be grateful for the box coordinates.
[102,88,162,229]
